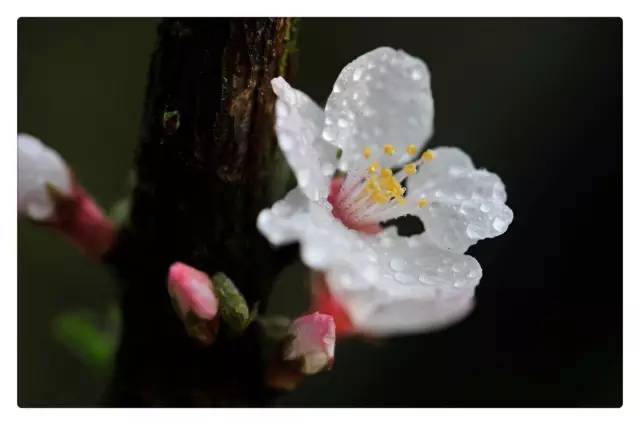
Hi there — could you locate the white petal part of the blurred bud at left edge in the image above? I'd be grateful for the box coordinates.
[18,133,72,221]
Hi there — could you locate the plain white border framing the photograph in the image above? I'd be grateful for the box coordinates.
[0,0,640,425]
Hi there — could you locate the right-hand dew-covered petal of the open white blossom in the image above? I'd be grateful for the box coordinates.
[407,147,513,253]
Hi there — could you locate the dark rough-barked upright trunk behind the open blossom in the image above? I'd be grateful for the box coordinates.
[106,18,295,406]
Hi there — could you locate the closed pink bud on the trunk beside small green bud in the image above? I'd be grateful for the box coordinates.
[168,262,219,344]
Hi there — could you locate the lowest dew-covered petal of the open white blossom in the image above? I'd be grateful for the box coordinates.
[327,229,482,336]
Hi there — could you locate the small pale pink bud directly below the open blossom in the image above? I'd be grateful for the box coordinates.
[284,312,336,375]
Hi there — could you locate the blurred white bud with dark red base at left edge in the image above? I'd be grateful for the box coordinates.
[18,134,115,258]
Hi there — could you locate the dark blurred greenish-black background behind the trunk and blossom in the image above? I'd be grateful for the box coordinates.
[18,18,622,406]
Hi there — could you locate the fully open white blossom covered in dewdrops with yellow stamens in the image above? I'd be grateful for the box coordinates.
[258,47,513,335]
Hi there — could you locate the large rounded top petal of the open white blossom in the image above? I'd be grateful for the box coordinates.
[322,47,434,171]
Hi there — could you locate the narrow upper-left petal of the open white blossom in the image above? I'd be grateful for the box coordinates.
[271,77,336,201]
